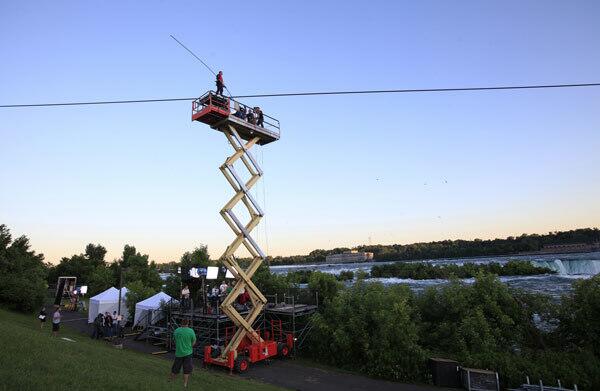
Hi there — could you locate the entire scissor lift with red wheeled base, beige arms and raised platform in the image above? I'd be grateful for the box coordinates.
[192,91,293,372]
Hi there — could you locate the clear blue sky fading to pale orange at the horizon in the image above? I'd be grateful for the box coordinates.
[0,0,600,262]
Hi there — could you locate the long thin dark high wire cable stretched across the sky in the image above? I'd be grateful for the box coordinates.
[0,83,600,108]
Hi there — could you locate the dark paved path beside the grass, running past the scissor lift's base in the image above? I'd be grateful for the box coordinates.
[56,307,456,391]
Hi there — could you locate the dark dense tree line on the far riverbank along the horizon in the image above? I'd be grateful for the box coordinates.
[271,228,600,265]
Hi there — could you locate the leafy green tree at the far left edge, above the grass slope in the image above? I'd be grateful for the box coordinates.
[0,224,48,312]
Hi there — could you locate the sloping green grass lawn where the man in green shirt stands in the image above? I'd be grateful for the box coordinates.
[0,309,281,391]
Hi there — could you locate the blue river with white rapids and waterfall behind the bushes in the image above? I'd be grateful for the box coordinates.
[271,252,600,298]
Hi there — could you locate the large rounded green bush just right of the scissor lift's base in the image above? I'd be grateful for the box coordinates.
[309,282,426,381]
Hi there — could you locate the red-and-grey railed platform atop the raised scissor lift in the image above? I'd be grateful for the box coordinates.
[192,91,280,145]
